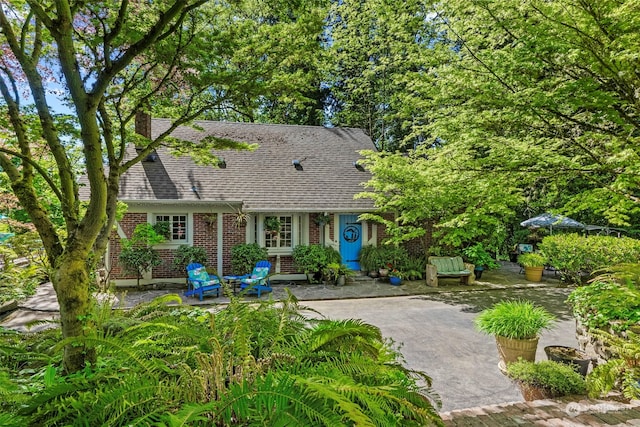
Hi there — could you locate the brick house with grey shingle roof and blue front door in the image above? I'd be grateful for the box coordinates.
[105,115,384,285]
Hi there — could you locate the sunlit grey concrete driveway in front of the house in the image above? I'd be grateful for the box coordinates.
[302,288,577,411]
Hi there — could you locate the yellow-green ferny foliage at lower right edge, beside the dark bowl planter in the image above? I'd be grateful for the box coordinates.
[587,330,640,399]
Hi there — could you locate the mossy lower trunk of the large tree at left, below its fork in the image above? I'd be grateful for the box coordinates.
[51,251,96,373]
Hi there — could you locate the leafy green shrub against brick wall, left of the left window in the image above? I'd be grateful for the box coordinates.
[118,223,165,286]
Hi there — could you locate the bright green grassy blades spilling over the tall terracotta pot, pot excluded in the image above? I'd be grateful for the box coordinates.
[474,301,556,339]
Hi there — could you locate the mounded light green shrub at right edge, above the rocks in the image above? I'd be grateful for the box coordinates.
[567,281,640,331]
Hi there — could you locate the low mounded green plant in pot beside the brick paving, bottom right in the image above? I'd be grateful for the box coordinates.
[506,360,586,401]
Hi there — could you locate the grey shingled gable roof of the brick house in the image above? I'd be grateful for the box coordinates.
[119,119,375,212]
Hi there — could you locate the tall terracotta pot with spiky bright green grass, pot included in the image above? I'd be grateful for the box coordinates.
[475,301,556,364]
